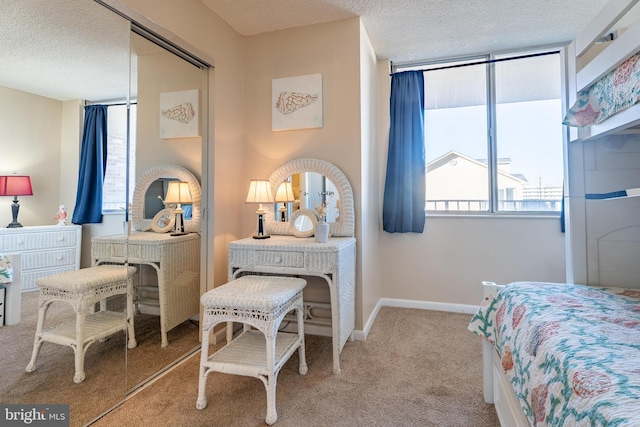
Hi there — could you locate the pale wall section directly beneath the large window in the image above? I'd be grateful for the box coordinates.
[381,216,565,305]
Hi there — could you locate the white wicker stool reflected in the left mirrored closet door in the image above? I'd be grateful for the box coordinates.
[27,265,137,384]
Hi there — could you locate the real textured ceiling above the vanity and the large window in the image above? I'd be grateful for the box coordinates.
[201,0,607,63]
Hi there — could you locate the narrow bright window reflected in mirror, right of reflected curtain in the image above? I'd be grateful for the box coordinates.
[102,104,137,212]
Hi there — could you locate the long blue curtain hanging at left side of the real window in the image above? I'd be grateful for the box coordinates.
[382,71,425,233]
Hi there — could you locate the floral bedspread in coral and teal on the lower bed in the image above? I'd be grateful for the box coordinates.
[469,282,640,427]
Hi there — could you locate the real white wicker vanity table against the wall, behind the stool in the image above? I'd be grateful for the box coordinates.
[227,235,356,374]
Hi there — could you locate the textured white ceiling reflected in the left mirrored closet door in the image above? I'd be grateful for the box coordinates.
[0,0,129,100]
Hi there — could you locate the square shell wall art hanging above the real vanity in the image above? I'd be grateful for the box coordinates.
[271,74,323,131]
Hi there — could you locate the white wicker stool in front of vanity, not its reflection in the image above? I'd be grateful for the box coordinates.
[196,276,307,424]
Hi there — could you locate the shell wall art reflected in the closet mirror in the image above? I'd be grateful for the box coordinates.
[160,89,200,139]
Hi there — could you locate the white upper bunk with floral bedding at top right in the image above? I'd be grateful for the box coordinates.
[563,0,640,140]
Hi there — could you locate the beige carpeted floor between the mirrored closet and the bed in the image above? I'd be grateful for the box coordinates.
[91,307,499,427]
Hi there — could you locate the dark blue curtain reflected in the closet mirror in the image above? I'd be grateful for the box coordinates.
[71,105,107,224]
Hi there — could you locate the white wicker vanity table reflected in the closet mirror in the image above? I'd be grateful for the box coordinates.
[91,232,200,347]
